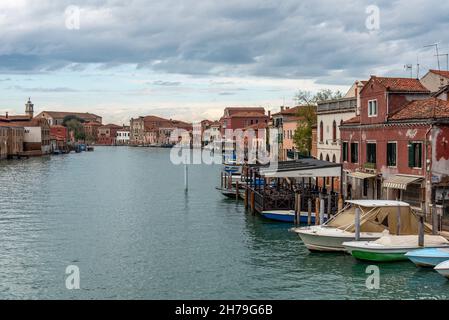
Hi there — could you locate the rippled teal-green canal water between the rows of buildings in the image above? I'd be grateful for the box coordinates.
[0,147,449,299]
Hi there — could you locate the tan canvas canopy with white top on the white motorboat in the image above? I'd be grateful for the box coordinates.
[324,200,431,235]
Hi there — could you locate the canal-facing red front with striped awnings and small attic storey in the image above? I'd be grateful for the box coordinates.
[340,76,430,206]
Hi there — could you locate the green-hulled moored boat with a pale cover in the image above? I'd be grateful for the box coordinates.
[343,235,449,262]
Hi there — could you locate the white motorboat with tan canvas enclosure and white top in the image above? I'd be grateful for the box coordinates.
[292,200,418,252]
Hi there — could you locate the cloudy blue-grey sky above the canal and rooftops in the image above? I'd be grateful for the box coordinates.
[0,0,449,124]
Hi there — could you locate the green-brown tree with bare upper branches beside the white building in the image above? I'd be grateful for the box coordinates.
[293,89,343,155]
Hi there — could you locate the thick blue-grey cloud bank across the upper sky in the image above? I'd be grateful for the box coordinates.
[0,0,449,85]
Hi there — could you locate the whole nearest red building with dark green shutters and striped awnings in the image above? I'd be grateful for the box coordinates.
[340,76,449,225]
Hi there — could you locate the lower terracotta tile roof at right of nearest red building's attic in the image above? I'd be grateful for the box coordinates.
[389,98,449,120]
